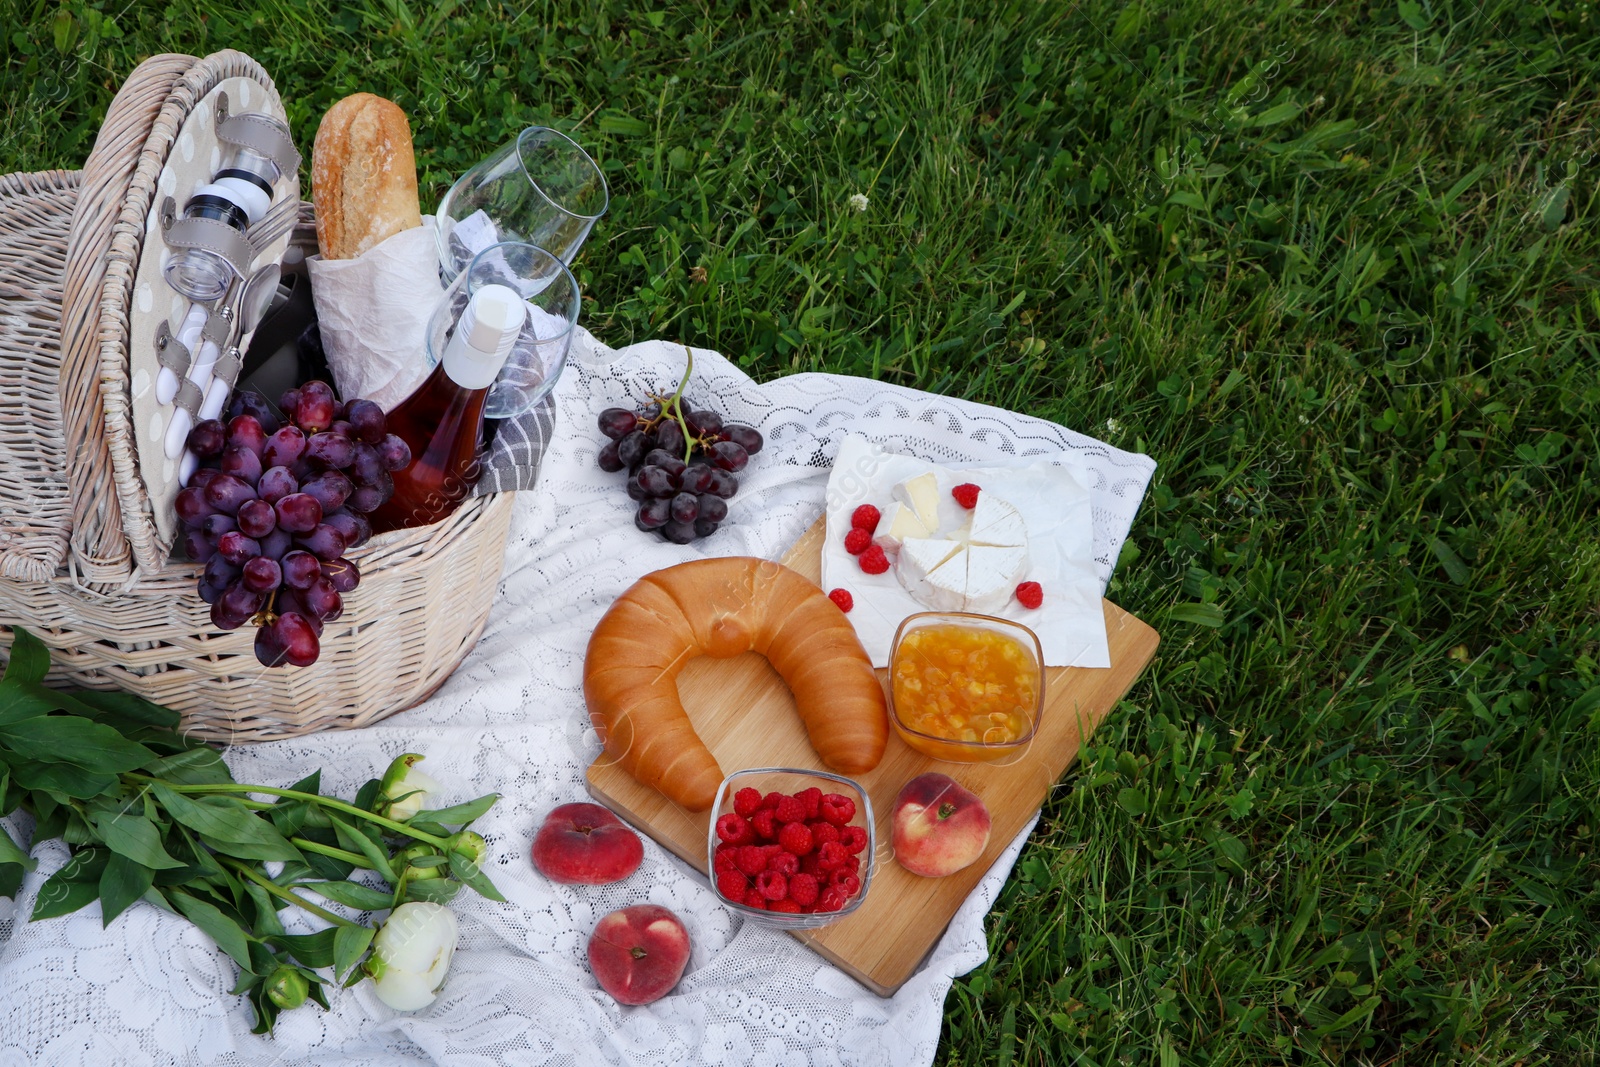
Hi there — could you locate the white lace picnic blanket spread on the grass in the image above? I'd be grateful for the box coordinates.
[0,334,1155,1067]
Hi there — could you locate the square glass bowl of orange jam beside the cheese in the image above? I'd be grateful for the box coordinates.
[890,611,1045,763]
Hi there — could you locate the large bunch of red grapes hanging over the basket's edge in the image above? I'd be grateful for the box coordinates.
[176,381,411,667]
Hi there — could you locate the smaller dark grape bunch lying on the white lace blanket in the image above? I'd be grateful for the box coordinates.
[598,404,763,544]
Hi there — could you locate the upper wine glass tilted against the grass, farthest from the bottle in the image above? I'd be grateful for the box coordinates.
[434,126,611,280]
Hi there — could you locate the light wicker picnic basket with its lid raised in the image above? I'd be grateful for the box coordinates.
[0,51,510,742]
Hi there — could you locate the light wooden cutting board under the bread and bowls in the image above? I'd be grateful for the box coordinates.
[587,520,1160,997]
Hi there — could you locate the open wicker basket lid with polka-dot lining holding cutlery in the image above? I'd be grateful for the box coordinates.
[61,51,299,585]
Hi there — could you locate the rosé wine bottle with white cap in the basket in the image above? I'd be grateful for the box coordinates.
[370,285,528,533]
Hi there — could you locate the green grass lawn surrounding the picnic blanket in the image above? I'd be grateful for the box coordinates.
[0,0,1600,1067]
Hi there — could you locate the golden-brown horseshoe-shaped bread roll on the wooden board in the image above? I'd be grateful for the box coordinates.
[584,557,888,811]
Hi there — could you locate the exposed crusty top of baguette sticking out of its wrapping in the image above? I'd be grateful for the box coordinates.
[310,93,422,259]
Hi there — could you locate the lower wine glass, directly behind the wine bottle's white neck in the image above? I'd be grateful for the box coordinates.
[427,242,581,419]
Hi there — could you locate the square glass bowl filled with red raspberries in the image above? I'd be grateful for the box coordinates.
[706,766,877,929]
